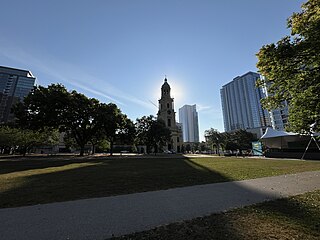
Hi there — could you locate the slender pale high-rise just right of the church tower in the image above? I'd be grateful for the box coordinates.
[179,105,199,142]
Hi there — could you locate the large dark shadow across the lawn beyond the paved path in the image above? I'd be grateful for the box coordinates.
[0,156,238,208]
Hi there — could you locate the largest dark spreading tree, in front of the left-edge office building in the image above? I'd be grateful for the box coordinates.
[14,84,106,156]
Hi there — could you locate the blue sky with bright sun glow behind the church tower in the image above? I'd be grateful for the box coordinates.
[0,0,305,140]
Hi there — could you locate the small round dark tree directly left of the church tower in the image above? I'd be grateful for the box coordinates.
[136,115,171,153]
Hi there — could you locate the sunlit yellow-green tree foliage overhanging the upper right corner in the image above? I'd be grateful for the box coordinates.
[257,0,320,133]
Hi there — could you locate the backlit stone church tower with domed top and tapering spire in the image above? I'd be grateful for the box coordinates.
[157,78,183,152]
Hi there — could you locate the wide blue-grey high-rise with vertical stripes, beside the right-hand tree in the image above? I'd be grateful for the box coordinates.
[220,72,271,137]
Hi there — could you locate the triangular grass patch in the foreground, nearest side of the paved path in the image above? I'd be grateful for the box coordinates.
[114,190,320,240]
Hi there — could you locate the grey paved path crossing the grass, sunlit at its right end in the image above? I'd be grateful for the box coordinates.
[0,171,320,240]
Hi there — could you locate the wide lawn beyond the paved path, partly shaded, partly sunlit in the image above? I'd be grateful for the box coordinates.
[0,155,320,208]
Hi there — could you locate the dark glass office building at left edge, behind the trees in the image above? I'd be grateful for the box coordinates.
[0,66,35,123]
